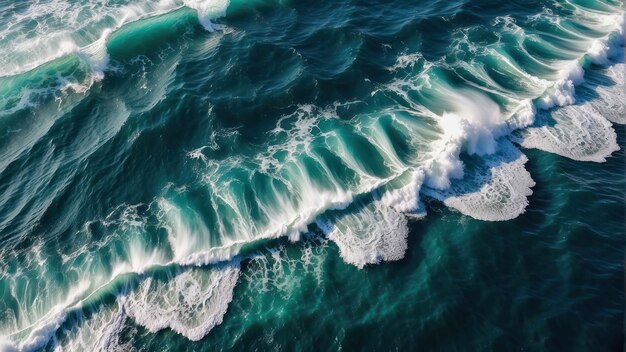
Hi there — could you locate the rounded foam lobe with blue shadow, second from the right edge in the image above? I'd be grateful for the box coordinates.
[422,139,535,221]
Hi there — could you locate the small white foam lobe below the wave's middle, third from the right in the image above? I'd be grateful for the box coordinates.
[316,201,409,268]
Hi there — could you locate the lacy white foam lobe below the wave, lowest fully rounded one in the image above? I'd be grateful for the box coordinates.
[124,261,239,341]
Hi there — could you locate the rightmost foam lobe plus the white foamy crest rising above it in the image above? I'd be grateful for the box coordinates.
[512,15,625,162]
